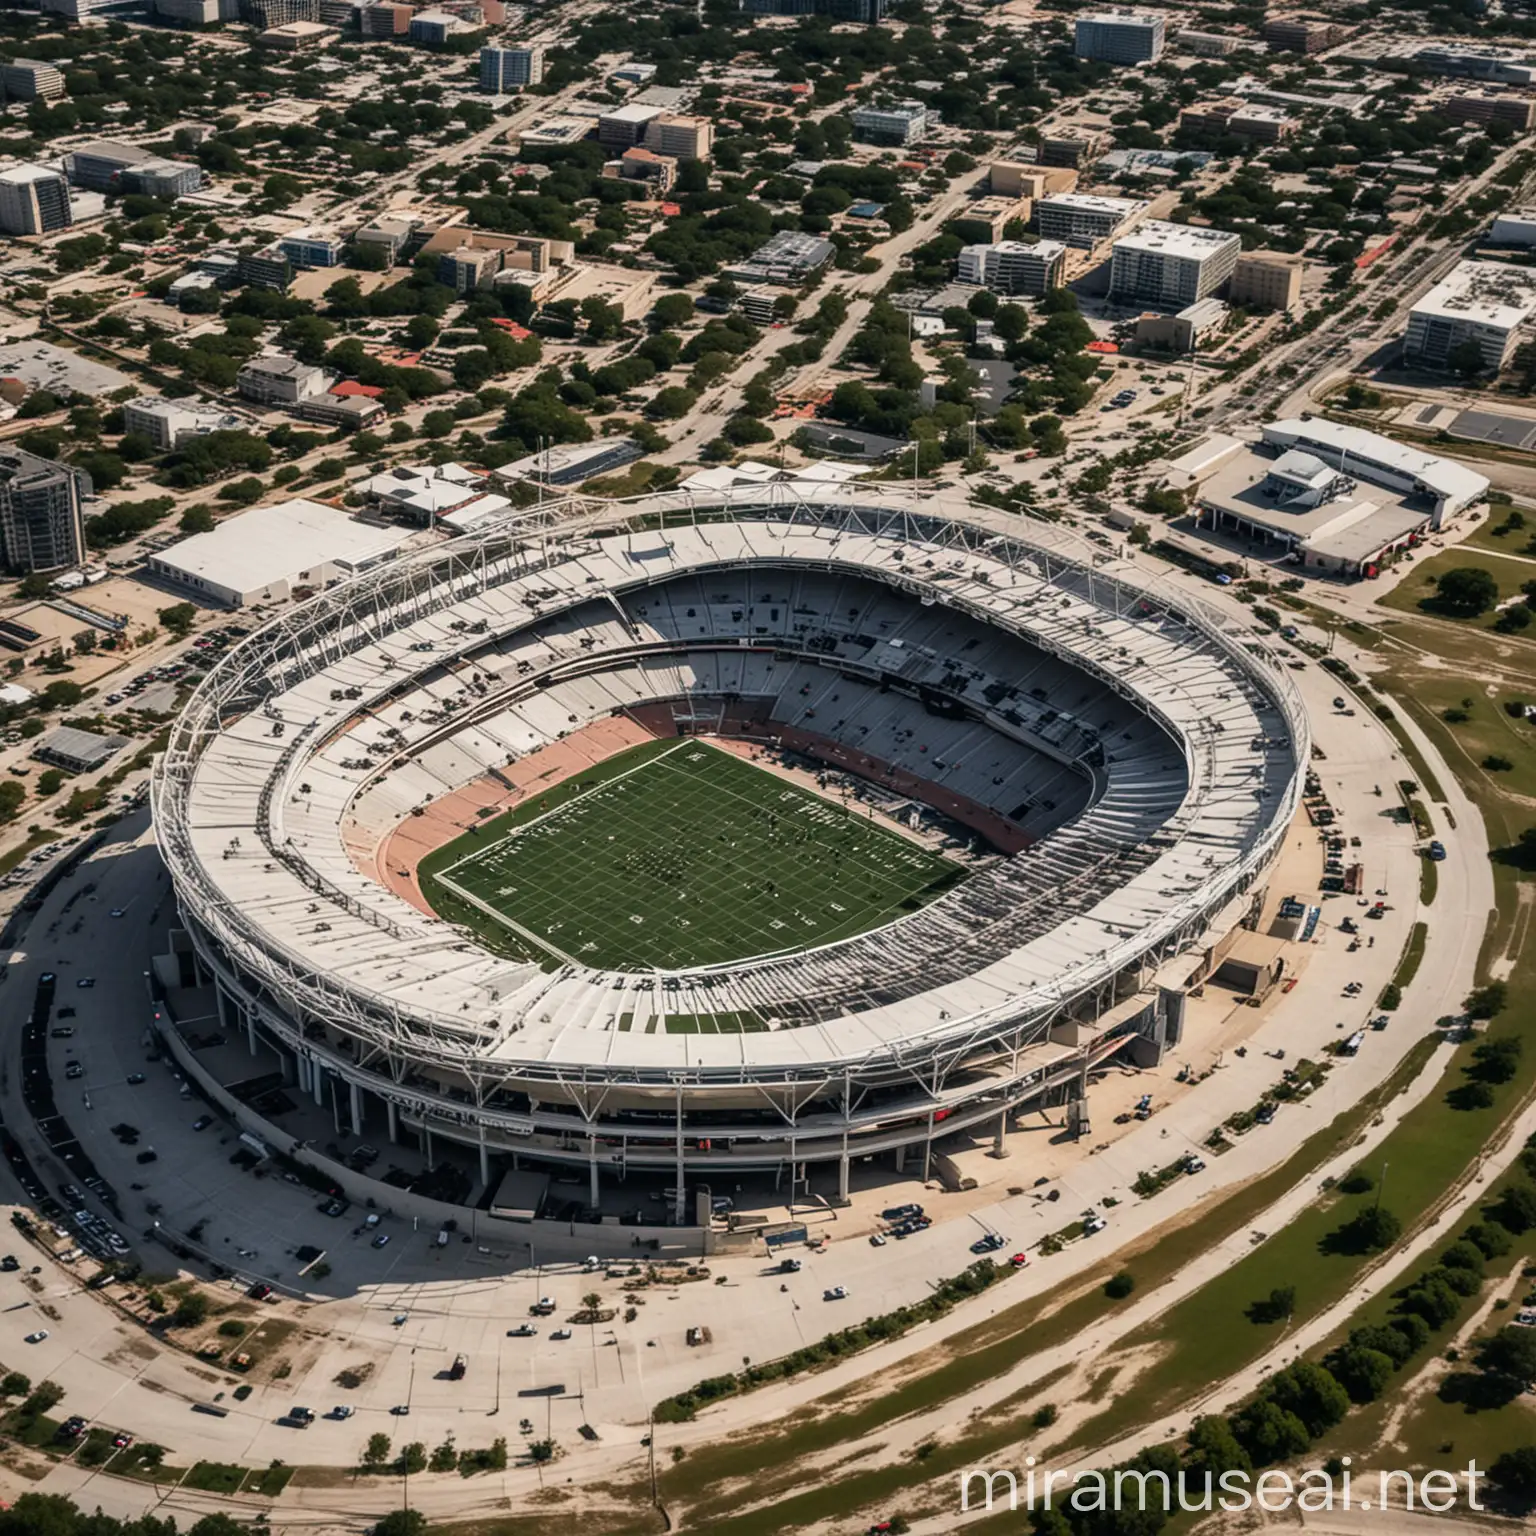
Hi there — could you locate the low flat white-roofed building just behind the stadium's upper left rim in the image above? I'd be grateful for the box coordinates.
[147,499,410,608]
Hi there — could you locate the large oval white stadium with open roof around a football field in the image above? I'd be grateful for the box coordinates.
[154,484,1309,1223]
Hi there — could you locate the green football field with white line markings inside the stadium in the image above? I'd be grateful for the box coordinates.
[421,737,965,969]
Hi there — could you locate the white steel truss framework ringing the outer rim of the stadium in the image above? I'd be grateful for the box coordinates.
[152,485,1309,1166]
